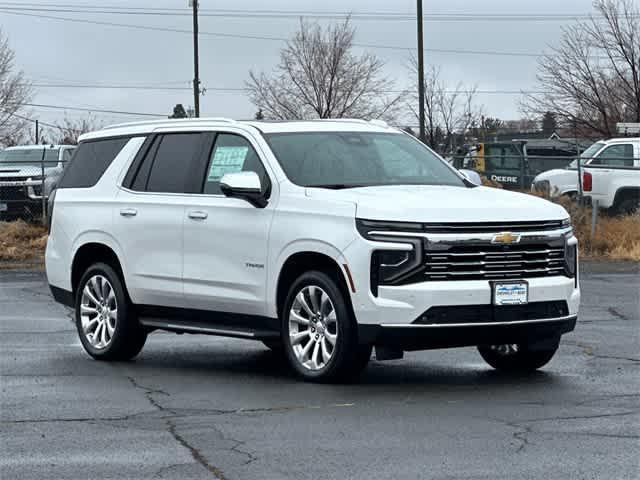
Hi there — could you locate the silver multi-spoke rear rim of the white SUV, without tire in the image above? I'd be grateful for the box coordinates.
[80,275,118,350]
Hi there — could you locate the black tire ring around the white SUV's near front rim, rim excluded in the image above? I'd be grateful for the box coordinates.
[280,271,358,382]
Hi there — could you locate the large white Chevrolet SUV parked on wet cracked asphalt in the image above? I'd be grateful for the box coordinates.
[46,119,580,380]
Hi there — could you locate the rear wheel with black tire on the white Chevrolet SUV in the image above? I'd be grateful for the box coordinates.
[75,263,147,361]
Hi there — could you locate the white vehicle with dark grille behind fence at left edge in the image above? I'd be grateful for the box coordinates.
[0,145,75,220]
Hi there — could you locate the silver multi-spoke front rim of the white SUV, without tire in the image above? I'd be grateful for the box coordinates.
[289,285,338,370]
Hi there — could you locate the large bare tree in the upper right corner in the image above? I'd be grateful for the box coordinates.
[523,0,640,136]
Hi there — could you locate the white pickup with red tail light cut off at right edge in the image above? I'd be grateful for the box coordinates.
[582,138,640,215]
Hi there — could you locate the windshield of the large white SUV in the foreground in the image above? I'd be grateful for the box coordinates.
[266,132,465,188]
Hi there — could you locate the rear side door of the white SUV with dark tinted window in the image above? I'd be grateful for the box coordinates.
[113,133,204,307]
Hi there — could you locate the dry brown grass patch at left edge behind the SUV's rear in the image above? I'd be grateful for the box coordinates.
[0,220,47,262]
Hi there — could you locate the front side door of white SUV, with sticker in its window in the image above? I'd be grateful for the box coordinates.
[183,133,277,315]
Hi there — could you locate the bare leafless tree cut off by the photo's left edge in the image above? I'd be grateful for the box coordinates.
[0,30,31,145]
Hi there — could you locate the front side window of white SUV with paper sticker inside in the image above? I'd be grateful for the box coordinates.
[202,133,268,195]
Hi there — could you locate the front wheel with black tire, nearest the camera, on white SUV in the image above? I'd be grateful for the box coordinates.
[280,271,372,382]
